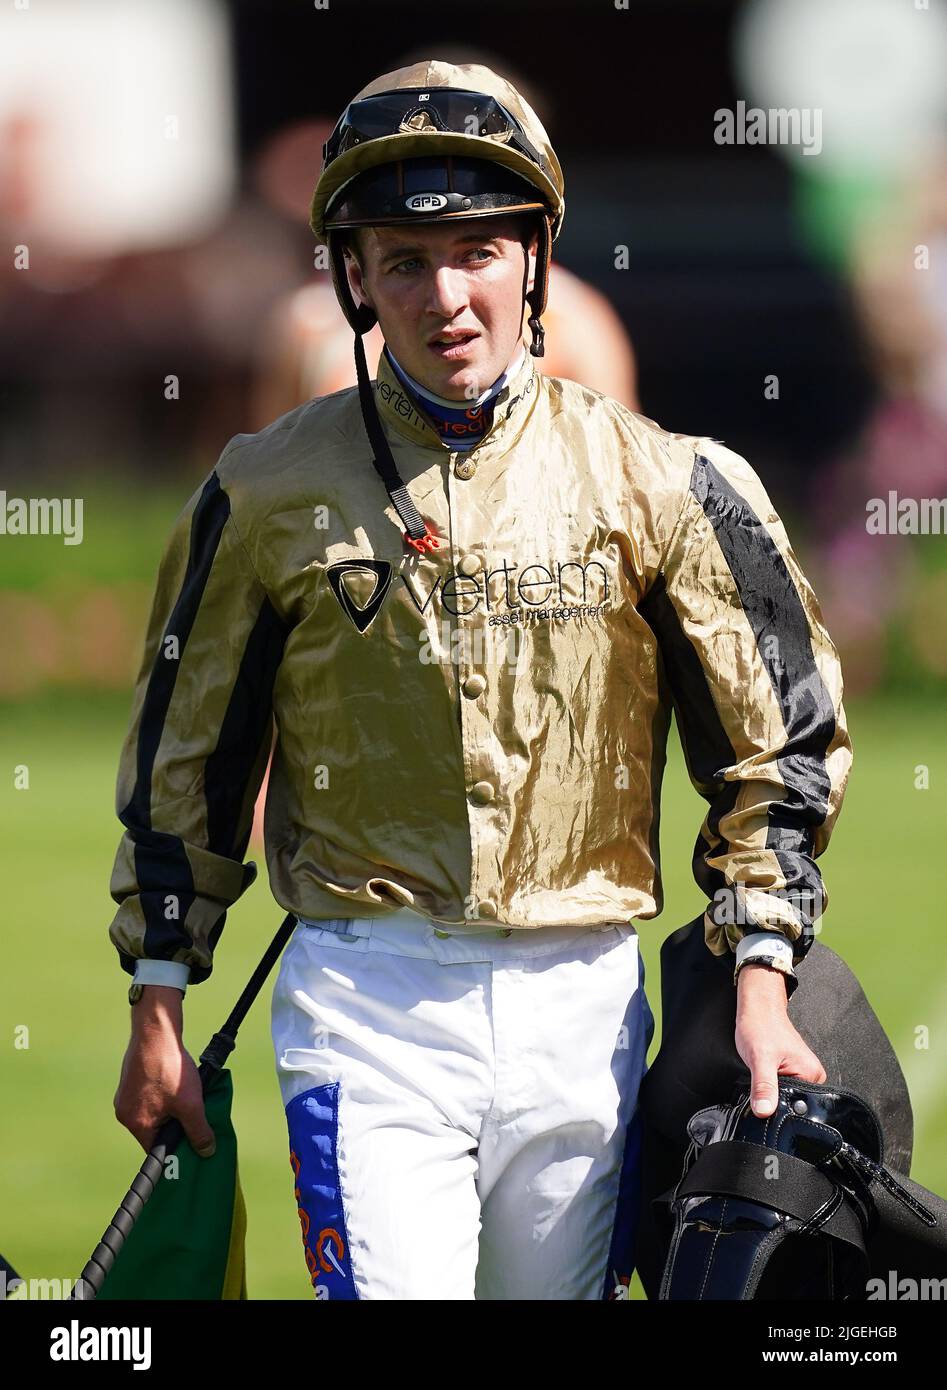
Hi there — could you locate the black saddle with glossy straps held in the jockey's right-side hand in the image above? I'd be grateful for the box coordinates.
[637,917,947,1300]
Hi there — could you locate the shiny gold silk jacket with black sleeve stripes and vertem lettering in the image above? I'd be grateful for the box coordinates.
[110,341,851,981]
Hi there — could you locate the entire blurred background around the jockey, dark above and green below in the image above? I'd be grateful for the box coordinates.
[0,0,947,1298]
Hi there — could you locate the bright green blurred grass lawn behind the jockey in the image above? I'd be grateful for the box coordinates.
[0,478,947,1300]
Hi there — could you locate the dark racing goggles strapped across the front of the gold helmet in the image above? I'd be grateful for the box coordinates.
[323,88,547,172]
